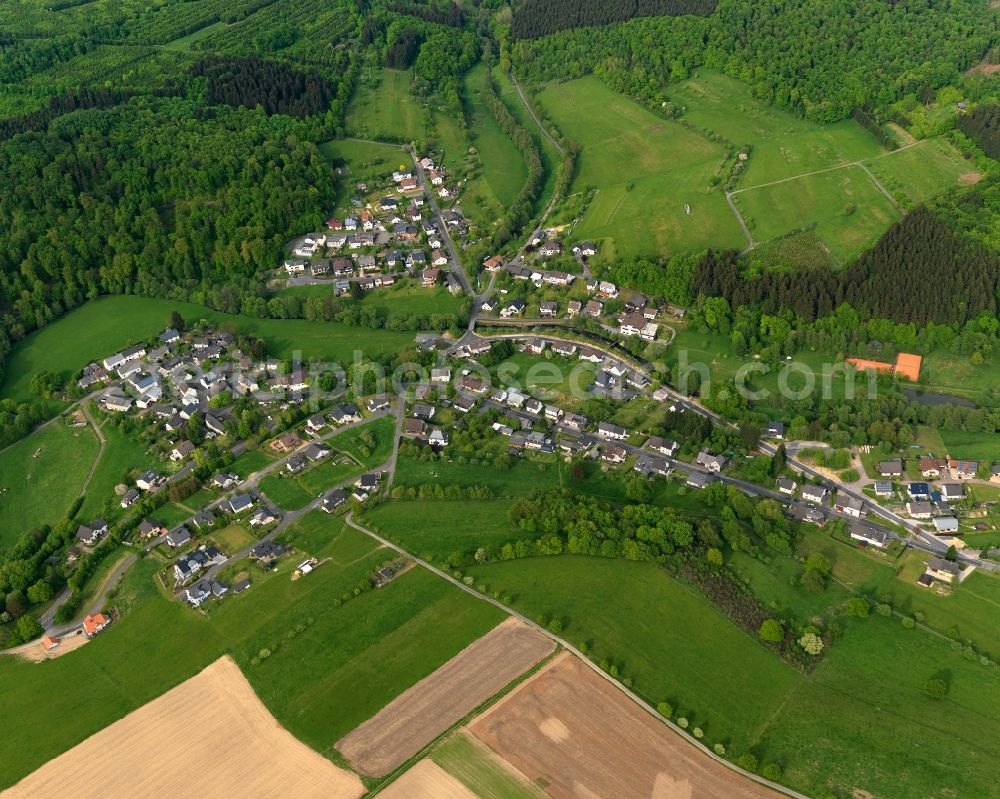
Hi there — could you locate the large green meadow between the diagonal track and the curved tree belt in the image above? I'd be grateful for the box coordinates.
[470,555,800,748]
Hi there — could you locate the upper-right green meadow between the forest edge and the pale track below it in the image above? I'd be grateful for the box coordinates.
[669,69,885,187]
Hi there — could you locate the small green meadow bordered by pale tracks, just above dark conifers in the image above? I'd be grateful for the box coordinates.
[733,166,900,264]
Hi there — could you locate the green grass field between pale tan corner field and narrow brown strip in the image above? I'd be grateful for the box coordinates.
[232,553,504,756]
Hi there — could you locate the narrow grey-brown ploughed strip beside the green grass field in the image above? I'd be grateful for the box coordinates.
[337,619,554,777]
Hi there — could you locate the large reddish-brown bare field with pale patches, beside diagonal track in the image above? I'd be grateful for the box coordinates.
[469,655,778,799]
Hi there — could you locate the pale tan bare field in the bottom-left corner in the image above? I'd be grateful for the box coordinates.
[3,657,365,799]
